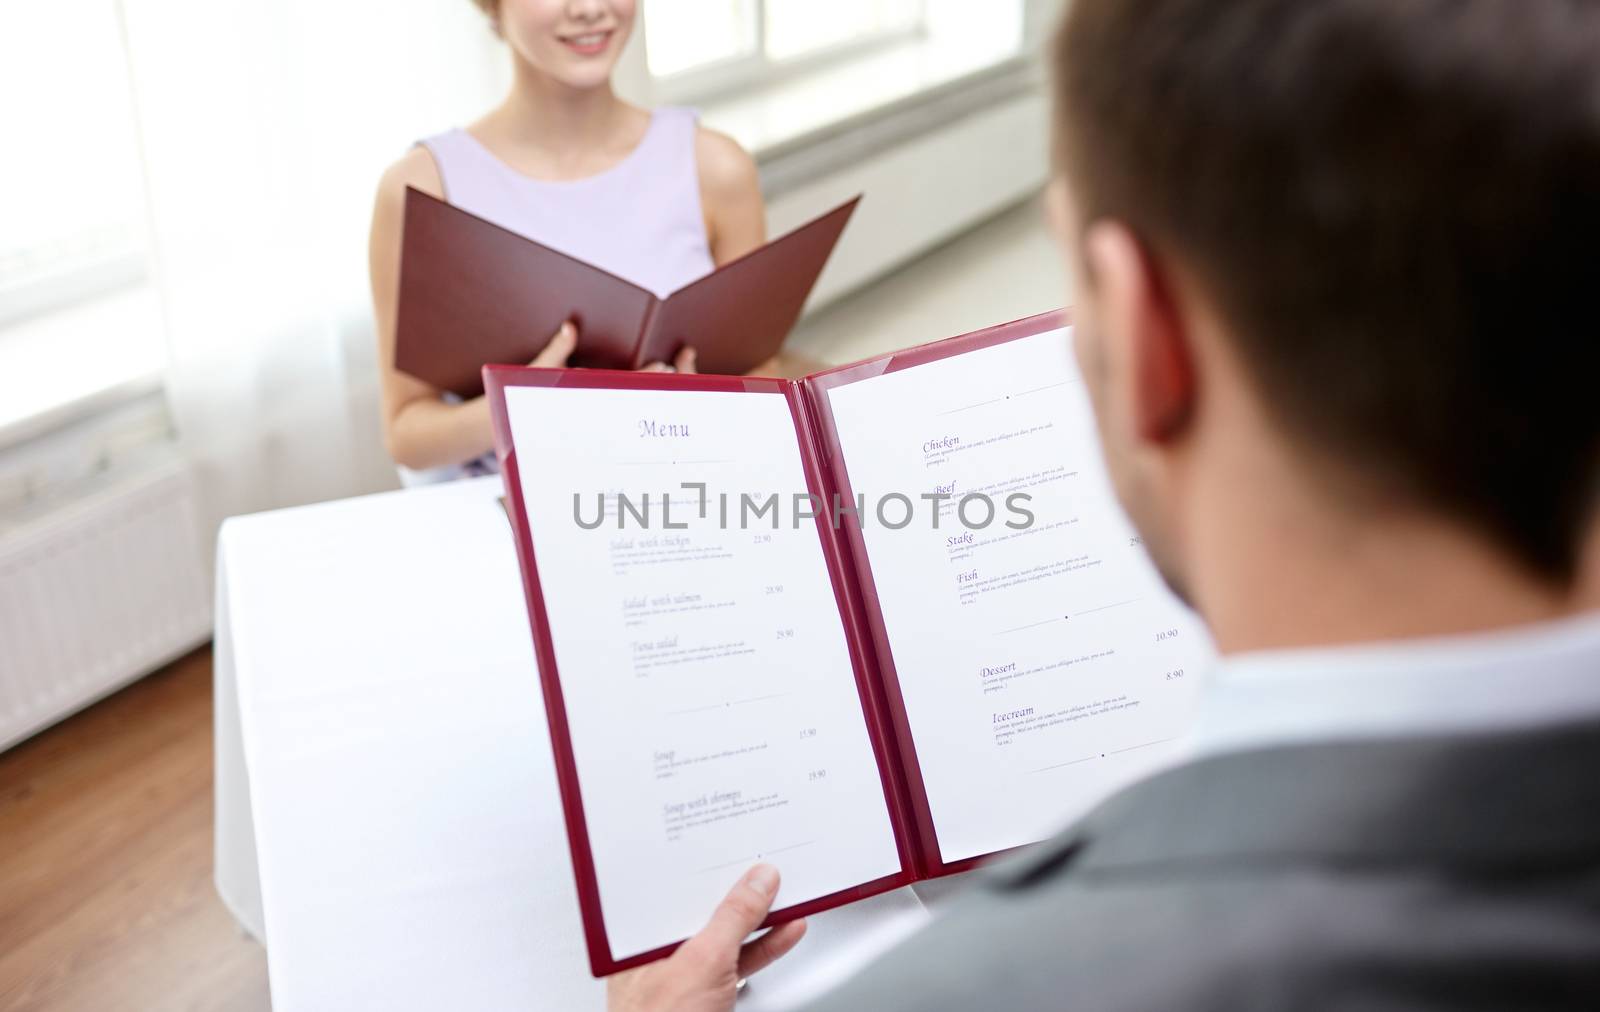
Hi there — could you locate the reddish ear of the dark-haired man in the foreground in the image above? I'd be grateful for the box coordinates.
[1083,221,1195,444]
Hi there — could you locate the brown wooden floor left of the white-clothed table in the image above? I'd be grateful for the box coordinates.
[0,650,269,1012]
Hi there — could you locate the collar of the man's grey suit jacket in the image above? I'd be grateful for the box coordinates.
[992,720,1600,887]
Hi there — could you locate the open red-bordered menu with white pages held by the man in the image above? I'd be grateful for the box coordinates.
[485,314,1211,975]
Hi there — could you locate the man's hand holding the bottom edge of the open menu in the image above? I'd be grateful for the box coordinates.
[606,865,805,1012]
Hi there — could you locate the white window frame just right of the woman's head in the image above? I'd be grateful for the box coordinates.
[645,0,928,104]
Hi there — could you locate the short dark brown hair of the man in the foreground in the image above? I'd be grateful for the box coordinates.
[1054,0,1600,581]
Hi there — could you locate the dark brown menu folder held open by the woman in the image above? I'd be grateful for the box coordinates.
[395,187,861,397]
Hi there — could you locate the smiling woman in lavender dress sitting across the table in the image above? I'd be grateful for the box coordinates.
[371,0,766,480]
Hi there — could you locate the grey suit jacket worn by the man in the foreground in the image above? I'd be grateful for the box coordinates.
[814,723,1600,1012]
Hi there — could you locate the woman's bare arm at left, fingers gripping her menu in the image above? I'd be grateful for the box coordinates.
[368,147,578,471]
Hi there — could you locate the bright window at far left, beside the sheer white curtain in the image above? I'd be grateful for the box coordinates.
[0,0,165,442]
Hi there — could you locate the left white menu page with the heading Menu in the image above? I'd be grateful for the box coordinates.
[506,386,901,959]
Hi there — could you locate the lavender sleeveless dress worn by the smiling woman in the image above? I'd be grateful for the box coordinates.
[400,106,714,485]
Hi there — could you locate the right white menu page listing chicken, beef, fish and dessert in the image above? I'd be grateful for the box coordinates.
[827,330,1211,861]
